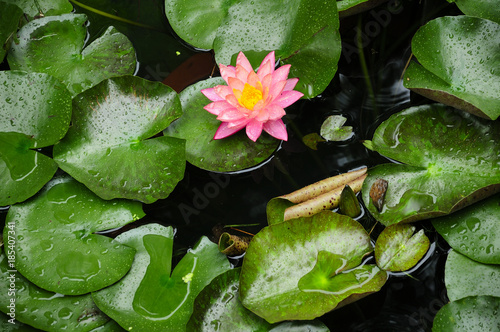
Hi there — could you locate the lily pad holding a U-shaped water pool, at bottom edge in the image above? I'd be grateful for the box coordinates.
[92,224,230,332]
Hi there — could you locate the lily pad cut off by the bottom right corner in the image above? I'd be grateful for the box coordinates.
[432,296,500,332]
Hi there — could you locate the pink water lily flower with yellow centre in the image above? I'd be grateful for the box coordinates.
[201,51,303,142]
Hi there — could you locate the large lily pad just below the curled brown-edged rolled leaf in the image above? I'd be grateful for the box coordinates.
[240,211,387,323]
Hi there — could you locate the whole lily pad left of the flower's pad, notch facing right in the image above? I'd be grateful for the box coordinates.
[54,76,186,203]
